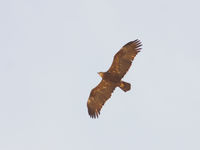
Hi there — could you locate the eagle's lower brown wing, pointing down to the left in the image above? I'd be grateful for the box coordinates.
[87,80,116,118]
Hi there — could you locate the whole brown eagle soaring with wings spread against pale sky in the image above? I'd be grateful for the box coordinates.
[87,39,142,118]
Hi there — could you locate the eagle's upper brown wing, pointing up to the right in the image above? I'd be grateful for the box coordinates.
[108,40,142,79]
